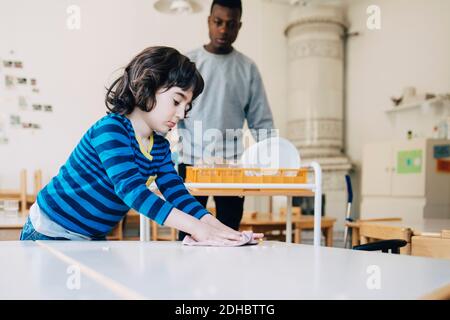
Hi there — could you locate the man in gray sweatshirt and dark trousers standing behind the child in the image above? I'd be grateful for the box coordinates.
[178,0,273,240]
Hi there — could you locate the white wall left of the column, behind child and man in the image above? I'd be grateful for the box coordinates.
[0,0,287,190]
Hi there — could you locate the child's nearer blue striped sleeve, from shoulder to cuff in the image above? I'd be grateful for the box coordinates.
[91,118,173,225]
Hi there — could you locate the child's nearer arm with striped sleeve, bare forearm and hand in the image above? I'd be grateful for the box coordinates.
[91,119,240,241]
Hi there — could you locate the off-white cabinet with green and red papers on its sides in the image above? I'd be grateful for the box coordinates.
[361,139,450,220]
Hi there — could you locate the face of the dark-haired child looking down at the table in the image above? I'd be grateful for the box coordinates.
[145,87,193,133]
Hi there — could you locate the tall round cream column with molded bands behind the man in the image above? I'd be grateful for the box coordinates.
[285,5,351,229]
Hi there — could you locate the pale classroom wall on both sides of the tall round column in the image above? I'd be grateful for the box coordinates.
[0,0,450,219]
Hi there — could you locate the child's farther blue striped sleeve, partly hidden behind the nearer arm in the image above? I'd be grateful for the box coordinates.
[156,140,209,219]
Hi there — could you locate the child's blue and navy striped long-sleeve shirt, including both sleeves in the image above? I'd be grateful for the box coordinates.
[37,114,208,237]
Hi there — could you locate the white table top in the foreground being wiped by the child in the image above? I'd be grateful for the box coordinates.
[0,241,450,299]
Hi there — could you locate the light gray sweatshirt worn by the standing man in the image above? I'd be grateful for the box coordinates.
[178,47,273,164]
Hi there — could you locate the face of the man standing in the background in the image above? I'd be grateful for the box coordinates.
[208,4,242,52]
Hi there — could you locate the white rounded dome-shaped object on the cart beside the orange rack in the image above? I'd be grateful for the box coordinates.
[241,137,300,169]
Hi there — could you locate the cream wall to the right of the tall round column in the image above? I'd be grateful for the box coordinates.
[345,0,450,215]
